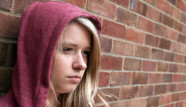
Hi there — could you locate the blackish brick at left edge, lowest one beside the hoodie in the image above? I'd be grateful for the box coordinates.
[0,68,12,94]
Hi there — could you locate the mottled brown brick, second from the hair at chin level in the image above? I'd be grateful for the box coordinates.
[119,86,138,100]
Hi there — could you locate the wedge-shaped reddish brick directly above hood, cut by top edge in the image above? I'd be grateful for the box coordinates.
[63,0,86,8]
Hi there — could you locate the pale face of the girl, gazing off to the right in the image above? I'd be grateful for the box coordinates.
[52,23,91,94]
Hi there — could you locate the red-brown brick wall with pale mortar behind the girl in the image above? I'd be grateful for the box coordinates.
[0,0,186,107]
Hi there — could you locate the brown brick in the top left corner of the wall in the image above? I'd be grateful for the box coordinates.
[0,0,12,11]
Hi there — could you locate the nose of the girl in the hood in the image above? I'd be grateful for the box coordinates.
[72,52,87,71]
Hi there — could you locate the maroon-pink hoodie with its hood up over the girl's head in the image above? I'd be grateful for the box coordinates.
[0,1,101,107]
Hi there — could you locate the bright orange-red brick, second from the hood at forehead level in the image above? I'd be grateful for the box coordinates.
[126,28,145,44]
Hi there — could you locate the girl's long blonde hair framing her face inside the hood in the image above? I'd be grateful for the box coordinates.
[46,17,109,107]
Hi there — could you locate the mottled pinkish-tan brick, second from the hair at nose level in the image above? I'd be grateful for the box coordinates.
[124,58,141,71]
